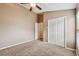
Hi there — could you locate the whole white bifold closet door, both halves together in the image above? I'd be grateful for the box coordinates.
[48,17,65,47]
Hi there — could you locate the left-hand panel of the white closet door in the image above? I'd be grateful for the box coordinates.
[48,20,57,44]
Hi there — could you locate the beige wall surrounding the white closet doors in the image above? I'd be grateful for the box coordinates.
[44,10,75,48]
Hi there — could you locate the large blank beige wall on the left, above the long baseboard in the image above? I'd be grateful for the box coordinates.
[0,4,36,48]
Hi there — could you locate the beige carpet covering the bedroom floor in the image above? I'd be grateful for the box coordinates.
[0,40,75,56]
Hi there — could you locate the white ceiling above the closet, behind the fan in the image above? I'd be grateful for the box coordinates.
[20,3,77,13]
